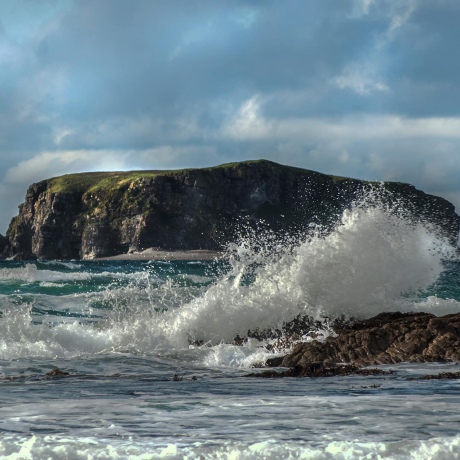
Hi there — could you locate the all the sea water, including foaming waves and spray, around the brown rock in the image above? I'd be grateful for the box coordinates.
[0,196,460,459]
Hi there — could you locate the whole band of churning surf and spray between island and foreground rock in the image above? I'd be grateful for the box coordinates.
[0,187,459,360]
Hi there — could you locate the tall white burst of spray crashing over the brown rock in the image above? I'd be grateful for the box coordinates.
[164,187,454,346]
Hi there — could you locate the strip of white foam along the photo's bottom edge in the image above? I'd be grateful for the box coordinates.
[0,435,460,460]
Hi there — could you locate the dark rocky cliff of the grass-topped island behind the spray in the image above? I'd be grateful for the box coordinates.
[3,160,460,259]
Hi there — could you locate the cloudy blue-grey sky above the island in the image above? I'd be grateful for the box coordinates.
[0,0,460,234]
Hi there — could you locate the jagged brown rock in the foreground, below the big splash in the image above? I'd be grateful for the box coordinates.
[281,312,460,376]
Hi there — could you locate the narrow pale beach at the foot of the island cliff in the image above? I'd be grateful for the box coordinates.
[96,248,224,261]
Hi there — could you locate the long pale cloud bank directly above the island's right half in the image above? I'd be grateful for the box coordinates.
[220,97,460,209]
